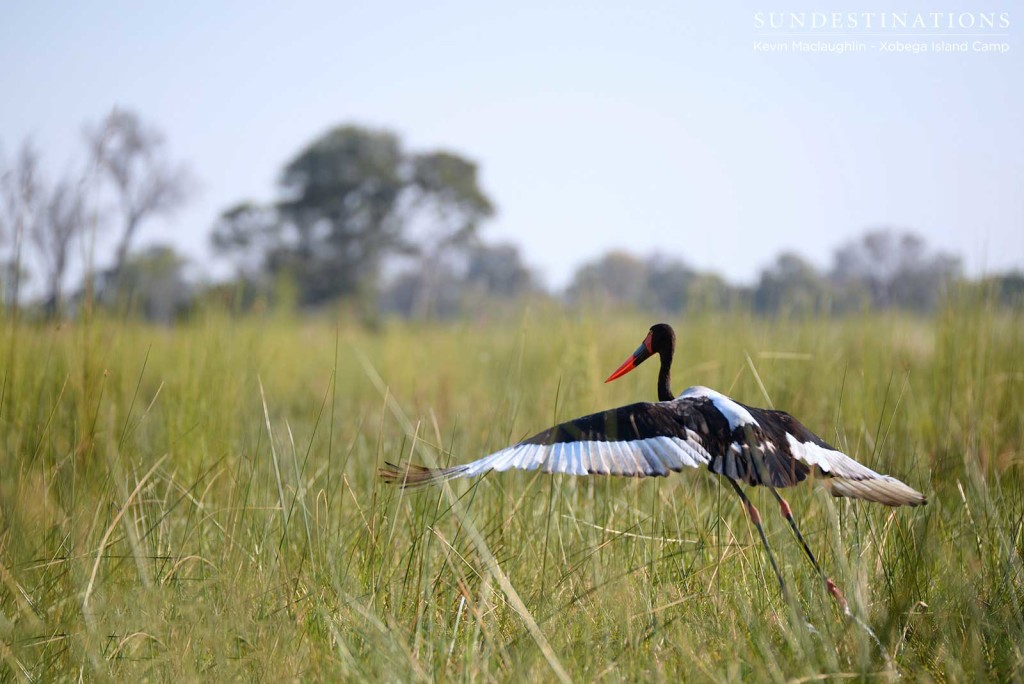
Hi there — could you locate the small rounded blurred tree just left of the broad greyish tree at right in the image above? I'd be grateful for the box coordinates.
[754,252,828,313]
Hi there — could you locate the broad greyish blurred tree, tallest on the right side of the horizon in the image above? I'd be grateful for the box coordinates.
[830,229,961,311]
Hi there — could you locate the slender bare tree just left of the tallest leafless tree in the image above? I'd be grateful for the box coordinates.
[30,178,86,316]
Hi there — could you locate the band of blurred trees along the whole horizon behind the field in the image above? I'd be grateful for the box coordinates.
[0,111,1024,322]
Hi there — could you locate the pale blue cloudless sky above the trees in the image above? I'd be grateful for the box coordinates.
[0,0,1024,287]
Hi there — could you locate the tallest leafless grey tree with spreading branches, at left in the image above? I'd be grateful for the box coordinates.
[85,110,193,283]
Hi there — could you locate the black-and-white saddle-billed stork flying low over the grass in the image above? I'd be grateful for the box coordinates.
[380,323,927,612]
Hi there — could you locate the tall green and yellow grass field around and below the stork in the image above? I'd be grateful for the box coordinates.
[0,302,1024,682]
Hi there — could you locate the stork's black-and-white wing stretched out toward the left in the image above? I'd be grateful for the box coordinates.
[380,400,711,486]
